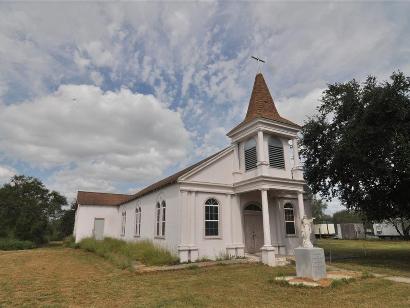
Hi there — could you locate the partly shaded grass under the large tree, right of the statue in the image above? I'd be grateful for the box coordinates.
[316,239,410,277]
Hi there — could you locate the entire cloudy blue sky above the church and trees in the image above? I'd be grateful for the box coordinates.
[0,2,410,211]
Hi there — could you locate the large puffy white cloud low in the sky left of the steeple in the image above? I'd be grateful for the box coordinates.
[0,85,190,195]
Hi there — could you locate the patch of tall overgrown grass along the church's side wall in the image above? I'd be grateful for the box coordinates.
[79,238,179,268]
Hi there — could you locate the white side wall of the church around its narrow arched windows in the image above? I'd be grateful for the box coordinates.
[118,184,180,254]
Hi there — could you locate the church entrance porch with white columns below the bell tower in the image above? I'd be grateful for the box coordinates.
[239,188,304,266]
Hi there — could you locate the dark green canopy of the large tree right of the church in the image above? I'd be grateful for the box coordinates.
[301,72,410,236]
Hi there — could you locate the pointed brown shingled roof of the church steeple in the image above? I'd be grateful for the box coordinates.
[232,73,300,131]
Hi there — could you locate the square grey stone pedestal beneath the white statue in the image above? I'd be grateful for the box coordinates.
[295,247,326,280]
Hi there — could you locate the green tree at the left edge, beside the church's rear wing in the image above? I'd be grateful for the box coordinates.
[0,175,67,244]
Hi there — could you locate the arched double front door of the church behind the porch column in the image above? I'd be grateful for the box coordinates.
[243,204,263,253]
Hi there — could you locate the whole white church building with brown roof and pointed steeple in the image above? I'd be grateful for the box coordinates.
[74,73,311,266]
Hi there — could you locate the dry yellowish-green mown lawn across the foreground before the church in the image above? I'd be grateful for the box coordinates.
[0,247,410,307]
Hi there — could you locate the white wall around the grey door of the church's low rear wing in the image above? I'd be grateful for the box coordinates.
[74,205,119,242]
